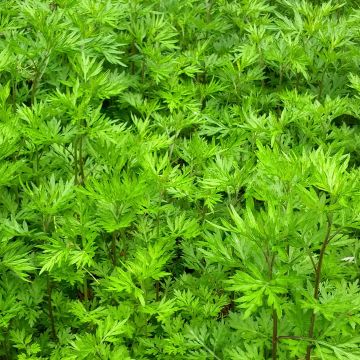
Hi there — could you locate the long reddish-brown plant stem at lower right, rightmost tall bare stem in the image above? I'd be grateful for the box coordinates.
[305,216,332,360]
